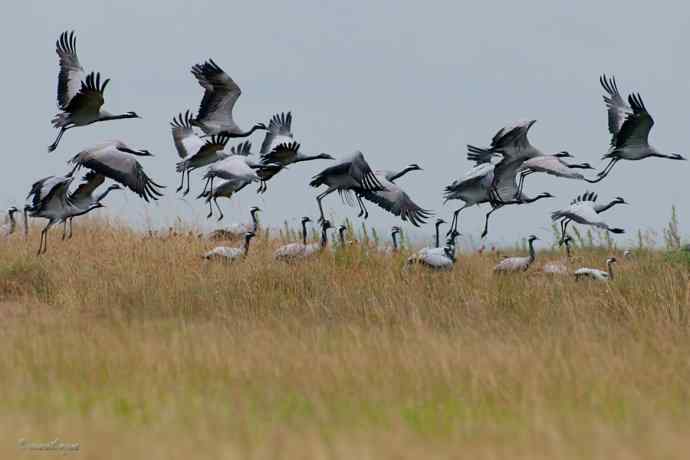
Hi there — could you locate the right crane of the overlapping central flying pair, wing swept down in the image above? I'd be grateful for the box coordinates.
[354,164,432,227]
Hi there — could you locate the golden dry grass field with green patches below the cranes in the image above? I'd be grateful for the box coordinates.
[0,219,690,460]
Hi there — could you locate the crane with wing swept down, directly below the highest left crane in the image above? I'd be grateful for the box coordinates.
[70,140,165,202]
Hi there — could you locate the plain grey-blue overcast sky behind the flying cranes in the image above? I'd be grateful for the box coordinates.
[0,0,690,246]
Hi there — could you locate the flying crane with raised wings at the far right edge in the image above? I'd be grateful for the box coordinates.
[597,75,687,181]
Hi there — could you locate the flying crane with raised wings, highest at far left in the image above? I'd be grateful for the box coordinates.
[48,31,140,152]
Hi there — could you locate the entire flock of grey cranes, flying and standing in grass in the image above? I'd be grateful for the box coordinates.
[5,32,685,279]
